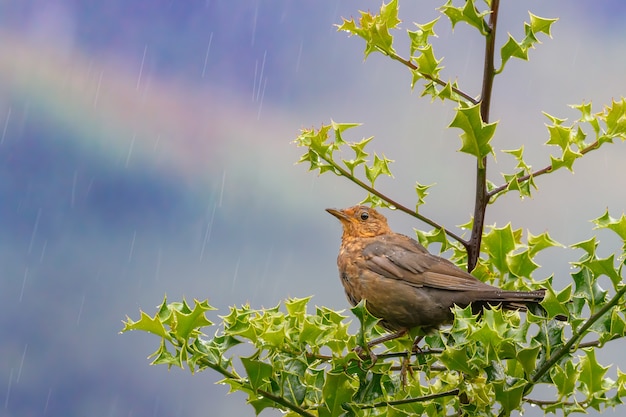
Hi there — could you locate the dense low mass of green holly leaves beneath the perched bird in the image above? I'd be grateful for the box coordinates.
[122,223,626,416]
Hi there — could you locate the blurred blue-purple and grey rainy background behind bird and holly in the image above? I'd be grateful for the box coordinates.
[0,0,626,416]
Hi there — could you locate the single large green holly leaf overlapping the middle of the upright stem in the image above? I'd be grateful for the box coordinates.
[450,104,497,166]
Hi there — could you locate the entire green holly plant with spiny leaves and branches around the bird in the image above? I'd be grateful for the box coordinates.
[123,0,626,416]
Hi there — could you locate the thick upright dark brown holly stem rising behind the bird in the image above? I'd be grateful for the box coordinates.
[467,0,500,271]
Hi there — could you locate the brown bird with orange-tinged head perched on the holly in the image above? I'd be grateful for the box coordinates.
[326,206,545,336]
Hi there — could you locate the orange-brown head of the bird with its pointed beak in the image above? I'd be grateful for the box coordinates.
[326,206,391,237]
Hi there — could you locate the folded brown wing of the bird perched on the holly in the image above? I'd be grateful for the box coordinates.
[363,234,492,291]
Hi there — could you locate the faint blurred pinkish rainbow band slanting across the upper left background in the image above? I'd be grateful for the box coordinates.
[0,31,297,184]
